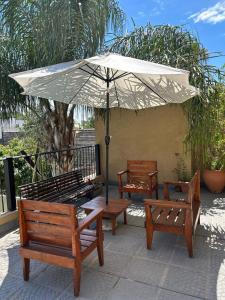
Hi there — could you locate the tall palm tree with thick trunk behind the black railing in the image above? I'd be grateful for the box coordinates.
[0,0,124,150]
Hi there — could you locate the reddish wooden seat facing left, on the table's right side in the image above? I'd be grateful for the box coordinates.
[145,171,200,257]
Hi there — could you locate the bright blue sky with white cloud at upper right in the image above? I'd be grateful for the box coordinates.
[119,0,225,67]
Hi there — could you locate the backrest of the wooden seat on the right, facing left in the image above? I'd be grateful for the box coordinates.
[186,170,200,204]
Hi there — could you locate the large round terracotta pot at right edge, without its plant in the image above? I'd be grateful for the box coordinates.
[203,170,225,193]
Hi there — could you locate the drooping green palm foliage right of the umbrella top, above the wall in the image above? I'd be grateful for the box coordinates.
[108,24,224,167]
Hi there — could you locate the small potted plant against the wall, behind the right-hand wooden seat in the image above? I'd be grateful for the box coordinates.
[174,153,191,193]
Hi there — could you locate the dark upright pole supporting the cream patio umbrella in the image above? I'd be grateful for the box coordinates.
[105,68,110,205]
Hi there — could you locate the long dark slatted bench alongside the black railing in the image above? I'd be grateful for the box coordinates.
[20,170,95,203]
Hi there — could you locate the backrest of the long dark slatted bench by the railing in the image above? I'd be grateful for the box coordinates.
[20,170,86,200]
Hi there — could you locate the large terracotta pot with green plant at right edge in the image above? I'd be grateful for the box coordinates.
[203,135,225,193]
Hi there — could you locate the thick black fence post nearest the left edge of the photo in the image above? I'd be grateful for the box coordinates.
[3,157,16,211]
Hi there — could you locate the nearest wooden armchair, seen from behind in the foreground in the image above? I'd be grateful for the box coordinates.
[18,200,104,296]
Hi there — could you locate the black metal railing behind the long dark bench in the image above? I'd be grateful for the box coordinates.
[0,145,100,213]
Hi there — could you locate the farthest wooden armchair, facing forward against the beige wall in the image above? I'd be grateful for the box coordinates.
[117,160,158,199]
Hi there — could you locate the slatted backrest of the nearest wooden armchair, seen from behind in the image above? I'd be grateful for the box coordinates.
[18,200,78,254]
